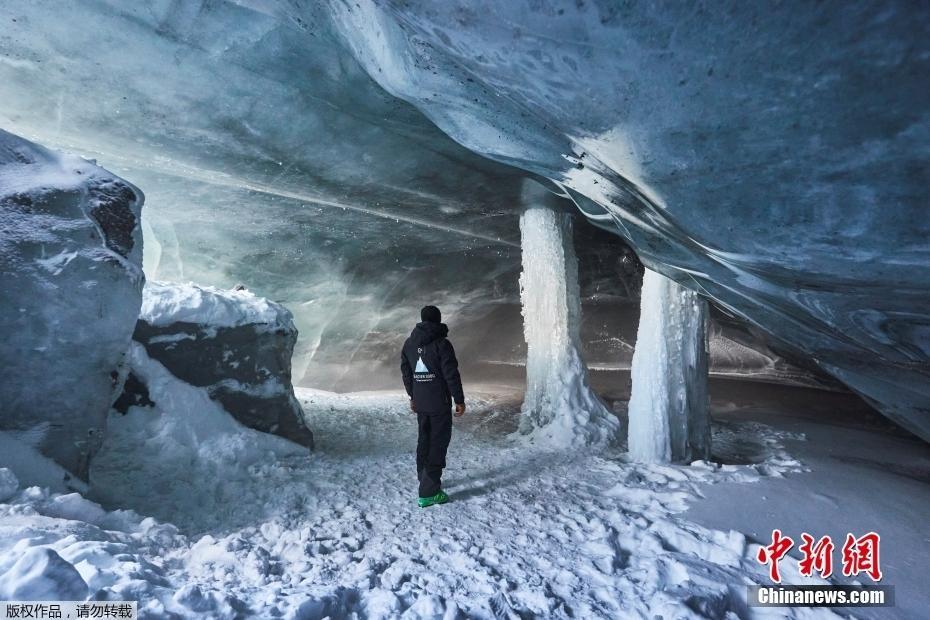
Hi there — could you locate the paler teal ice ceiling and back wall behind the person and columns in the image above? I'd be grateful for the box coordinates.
[0,0,812,402]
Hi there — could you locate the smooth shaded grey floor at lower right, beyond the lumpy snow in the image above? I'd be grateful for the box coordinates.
[683,384,930,620]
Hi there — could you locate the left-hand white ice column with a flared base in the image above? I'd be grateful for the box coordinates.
[520,186,619,446]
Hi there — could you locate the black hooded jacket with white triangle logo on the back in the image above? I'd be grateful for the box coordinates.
[400,322,465,413]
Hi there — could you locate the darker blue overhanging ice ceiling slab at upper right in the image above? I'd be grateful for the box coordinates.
[320,1,930,438]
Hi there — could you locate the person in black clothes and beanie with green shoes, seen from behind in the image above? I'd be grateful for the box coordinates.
[400,306,465,508]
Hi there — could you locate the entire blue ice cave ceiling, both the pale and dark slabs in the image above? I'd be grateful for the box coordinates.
[0,0,930,437]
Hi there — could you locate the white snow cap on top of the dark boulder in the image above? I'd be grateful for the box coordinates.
[139,282,294,331]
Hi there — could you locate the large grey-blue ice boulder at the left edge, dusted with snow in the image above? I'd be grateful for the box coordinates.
[0,130,144,478]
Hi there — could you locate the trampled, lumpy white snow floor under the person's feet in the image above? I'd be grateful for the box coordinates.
[0,376,926,619]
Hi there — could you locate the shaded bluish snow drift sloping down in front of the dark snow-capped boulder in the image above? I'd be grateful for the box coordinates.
[91,342,306,524]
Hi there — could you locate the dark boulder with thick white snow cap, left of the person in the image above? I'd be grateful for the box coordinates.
[133,282,313,447]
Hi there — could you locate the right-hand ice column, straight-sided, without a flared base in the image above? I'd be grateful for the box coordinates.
[629,269,710,463]
